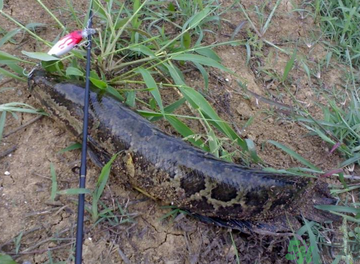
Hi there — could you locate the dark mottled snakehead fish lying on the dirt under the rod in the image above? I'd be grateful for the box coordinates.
[32,71,336,230]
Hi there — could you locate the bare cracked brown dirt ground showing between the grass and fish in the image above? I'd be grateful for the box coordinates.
[0,0,350,264]
